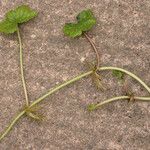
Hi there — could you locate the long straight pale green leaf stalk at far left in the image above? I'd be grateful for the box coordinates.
[17,27,29,106]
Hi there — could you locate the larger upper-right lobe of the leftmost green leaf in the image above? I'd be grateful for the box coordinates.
[6,5,37,24]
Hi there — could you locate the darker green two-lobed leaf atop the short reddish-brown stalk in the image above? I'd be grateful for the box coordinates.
[63,9,96,38]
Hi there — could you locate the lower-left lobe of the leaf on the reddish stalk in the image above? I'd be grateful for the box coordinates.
[63,23,82,38]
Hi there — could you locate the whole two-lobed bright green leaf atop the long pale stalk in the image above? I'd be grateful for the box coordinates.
[0,5,37,34]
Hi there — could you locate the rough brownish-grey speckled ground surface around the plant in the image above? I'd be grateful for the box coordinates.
[0,0,150,150]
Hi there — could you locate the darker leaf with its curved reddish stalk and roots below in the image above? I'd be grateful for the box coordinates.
[63,9,104,89]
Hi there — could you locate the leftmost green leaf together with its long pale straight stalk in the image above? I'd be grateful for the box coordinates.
[0,5,37,106]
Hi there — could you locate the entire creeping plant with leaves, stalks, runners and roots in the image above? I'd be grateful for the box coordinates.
[0,5,150,141]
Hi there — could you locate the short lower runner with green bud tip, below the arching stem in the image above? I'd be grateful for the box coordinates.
[89,96,150,111]
